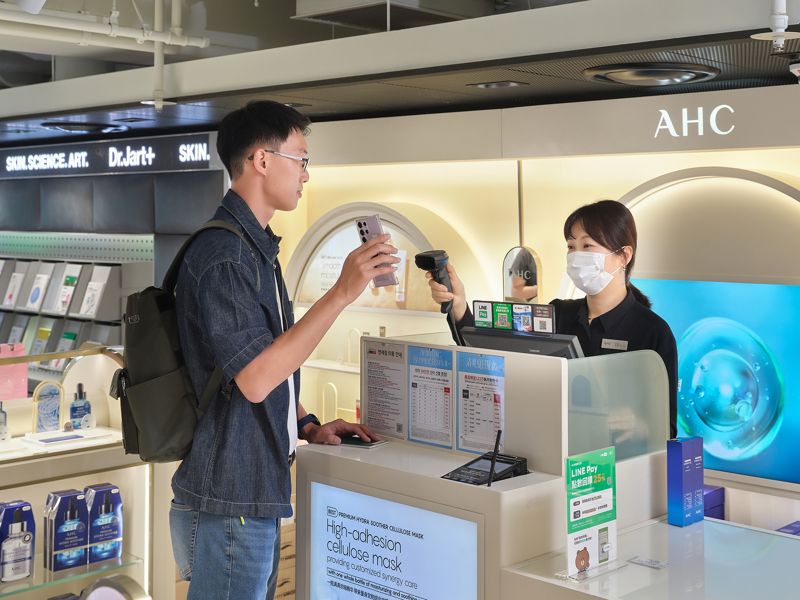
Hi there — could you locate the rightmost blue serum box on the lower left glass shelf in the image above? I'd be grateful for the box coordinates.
[84,483,122,563]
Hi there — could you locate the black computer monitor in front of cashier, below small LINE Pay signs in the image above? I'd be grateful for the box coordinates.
[461,327,583,358]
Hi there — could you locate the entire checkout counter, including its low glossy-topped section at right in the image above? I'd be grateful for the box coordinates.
[297,334,800,600]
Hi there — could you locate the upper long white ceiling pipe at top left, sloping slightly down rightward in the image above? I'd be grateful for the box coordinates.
[0,6,210,48]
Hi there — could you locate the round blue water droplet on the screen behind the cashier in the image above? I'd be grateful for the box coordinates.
[678,317,784,461]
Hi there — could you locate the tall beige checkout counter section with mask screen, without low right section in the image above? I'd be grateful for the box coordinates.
[297,334,668,600]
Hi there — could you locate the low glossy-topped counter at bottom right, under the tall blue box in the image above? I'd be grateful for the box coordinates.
[501,519,800,600]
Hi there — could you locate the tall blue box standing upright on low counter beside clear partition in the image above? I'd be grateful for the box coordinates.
[667,437,704,527]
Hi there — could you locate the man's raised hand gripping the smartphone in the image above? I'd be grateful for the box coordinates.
[333,233,400,304]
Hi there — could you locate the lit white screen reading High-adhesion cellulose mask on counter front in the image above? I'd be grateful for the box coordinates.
[310,482,478,600]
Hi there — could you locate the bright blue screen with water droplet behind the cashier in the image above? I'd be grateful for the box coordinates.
[634,279,800,483]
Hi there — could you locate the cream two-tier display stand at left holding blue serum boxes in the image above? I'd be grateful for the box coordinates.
[0,347,158,598]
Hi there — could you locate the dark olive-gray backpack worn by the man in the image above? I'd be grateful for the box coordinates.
[111,221,261,462]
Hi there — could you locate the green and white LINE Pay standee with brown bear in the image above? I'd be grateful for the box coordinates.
[565,447,617,576]
